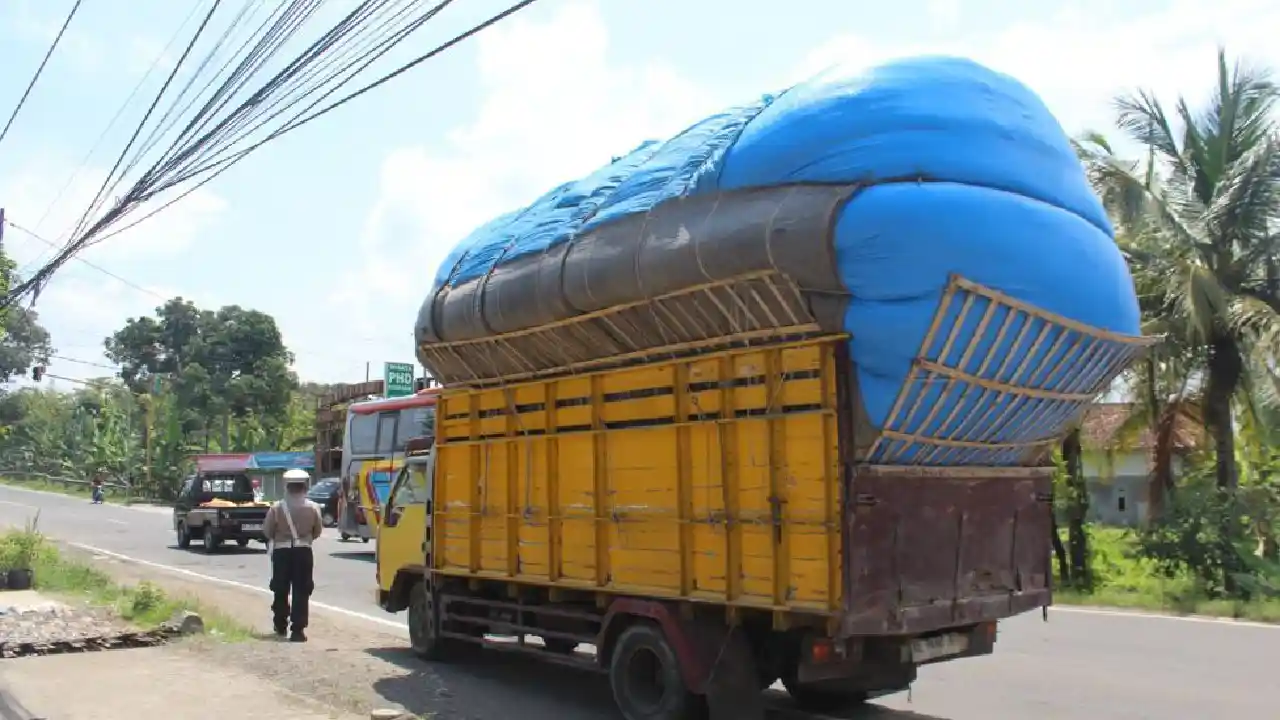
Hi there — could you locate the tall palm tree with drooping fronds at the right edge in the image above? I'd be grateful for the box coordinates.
[1079,50,1280,489]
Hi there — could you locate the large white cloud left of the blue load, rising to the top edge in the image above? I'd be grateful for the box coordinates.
[333,1,711,374]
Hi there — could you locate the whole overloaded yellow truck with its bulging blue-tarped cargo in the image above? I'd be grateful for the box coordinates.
[378,58,1149,720]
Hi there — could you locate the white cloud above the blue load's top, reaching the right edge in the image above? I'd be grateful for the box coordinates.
[792,0,1280,139]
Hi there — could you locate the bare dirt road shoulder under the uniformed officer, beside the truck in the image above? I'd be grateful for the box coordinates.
[64,547,617,720]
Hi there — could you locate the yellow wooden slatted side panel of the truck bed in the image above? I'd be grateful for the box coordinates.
[433,337,844,615]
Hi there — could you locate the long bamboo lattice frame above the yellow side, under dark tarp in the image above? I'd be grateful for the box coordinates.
[420,272,820,386]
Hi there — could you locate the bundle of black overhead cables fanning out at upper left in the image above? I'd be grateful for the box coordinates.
[0,0,534,307]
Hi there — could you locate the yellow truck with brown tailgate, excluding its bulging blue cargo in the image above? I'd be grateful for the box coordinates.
[378,284,1143,720]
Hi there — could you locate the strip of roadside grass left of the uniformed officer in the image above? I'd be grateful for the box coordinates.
[0,529,252,642]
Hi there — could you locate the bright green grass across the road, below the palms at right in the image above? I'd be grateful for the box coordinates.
[1053,527,1280,623]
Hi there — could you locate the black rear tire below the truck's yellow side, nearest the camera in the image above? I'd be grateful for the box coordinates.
[609,623,704,720]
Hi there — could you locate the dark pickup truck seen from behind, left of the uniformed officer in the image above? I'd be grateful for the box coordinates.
[173,473,269,553]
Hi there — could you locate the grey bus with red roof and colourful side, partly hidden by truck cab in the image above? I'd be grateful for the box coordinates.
[338,388,440,542]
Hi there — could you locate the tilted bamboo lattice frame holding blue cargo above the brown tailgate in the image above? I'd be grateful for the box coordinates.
[867,275,1157,466]
